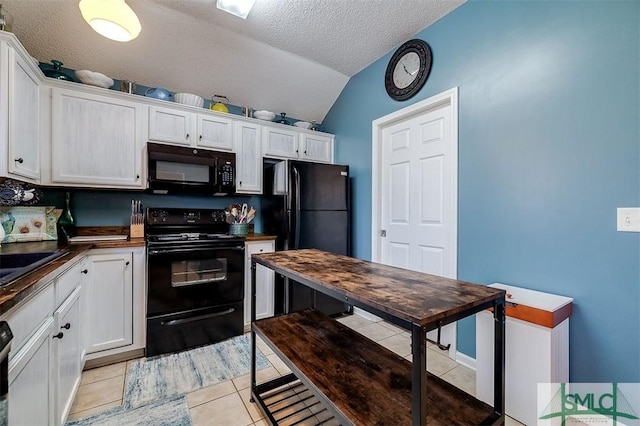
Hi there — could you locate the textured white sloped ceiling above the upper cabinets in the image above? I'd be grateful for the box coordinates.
[1,0,465,122]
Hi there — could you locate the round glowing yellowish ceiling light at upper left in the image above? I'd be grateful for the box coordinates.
[78,0,142,41]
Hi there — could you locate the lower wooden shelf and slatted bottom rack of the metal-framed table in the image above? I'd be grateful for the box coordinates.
[251,309,494,426]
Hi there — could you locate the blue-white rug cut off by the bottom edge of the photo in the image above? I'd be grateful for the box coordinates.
[66,396,191,426]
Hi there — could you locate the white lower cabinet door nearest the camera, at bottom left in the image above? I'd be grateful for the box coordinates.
[9,317,53,425]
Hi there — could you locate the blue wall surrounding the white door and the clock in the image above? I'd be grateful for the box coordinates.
[324,1,640,382]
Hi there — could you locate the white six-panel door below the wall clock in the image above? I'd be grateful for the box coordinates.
[374,92,458,358]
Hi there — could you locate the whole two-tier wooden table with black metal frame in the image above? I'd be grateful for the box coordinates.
[251,249,505,425]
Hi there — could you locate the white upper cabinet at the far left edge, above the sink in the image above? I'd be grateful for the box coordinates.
[0,36,41,183]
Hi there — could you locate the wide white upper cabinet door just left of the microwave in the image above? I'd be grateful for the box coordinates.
[51,88,143,189]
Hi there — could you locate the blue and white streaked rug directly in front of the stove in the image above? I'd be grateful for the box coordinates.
[123,335,269,409]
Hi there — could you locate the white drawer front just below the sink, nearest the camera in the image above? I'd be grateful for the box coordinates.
[7,284,54,358]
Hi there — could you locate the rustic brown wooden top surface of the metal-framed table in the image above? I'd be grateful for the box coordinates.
[252,249,505,328]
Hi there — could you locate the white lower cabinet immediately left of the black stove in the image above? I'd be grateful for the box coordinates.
[83,247,146,360]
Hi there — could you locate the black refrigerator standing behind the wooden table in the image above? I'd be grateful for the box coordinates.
[262,159,352,316]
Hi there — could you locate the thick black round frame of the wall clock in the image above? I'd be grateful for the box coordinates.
[384,39,432,101]
